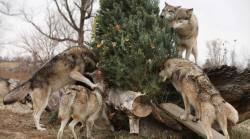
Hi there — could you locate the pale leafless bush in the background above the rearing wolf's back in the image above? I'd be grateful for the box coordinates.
[15,31,58,64]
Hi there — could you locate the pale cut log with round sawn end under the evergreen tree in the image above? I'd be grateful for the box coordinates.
[107,87,152,134]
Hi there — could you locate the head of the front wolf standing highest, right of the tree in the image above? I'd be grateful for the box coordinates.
[172,8,193,29]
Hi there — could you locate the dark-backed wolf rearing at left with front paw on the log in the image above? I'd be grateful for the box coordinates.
[3,47,98,130]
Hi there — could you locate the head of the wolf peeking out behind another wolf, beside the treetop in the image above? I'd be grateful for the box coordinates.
[160,2,181,23]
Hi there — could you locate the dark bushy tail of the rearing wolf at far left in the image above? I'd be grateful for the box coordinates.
[3,81,31,105]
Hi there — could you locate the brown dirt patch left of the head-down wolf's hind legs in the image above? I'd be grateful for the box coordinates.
[0,109,59,139]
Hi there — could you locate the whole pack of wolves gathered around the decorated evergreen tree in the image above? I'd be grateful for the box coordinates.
[0,2,239,139]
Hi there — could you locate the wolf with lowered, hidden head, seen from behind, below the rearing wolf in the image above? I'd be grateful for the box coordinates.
[57,70,114,139]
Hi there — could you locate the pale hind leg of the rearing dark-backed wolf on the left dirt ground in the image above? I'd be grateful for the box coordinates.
[31,87,51,131]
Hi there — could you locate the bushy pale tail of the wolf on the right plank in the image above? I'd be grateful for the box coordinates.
[220,102,239,124]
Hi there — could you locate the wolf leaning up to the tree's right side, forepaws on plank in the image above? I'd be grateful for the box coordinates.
[159,58,239,139]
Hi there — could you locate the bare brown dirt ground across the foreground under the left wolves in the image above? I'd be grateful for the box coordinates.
[0,102,145,139]
